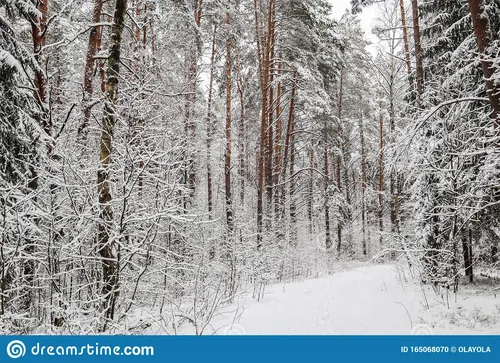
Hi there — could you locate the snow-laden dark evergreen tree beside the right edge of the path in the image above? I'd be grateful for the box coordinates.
[406,1,496,289]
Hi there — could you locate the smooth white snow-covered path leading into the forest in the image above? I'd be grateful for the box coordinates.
[212,265,423,334]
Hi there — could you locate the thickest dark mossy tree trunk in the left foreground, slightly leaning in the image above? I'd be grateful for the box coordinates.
[97,0,127,330]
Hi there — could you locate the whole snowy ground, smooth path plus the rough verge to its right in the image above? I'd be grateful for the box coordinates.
[170,265,500,334]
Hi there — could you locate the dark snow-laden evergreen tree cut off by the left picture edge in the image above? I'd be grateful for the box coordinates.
[0,0,42,329]
